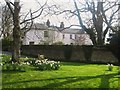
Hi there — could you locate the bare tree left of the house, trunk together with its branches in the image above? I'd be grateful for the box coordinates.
[5,0,47,63]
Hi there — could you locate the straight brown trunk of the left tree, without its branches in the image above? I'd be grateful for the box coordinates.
[12,2,21,63]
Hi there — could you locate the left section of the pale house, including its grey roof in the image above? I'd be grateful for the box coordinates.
[22,23,61,45]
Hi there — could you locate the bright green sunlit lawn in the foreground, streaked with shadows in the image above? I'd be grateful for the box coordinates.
[2,62,120,90]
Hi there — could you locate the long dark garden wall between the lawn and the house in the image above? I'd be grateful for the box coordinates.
[21,45,118,63]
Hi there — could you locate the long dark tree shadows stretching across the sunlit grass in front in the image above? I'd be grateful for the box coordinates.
[3,73,119,88]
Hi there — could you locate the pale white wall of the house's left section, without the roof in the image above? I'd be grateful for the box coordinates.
[23,30,61,45]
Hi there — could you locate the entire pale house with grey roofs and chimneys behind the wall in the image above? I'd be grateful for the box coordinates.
[22,22,92,45]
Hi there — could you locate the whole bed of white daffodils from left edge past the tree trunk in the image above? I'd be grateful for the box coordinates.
[0,55,60,71]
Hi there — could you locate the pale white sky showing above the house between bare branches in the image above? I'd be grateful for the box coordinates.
[0,0,119,27]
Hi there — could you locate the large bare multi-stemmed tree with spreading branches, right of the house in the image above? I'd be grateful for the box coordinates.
[50,0,120,45]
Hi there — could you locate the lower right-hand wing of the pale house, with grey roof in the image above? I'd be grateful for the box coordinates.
[61,28,87,45]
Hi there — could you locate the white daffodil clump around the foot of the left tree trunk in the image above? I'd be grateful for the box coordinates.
[0,54,30,72]
